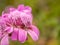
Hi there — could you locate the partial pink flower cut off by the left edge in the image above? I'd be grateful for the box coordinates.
[0,17,9,45]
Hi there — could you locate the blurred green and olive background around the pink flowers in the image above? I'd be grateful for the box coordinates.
[0,0,60,45]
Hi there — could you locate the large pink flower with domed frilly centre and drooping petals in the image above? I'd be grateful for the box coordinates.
[2,5,39,43]
